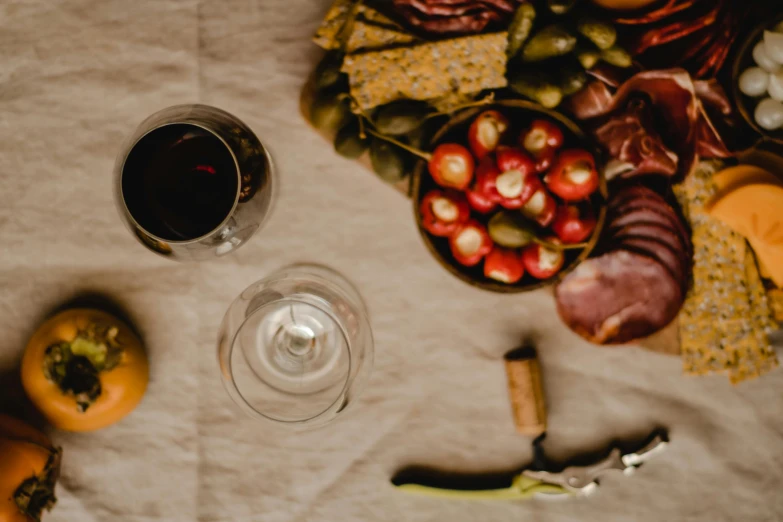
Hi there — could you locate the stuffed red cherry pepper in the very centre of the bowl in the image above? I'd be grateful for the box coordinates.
[495,147,540,209]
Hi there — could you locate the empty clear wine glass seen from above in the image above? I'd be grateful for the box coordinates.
[218,264,373,426]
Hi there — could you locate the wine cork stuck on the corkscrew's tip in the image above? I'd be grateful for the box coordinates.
[504,347,546,437]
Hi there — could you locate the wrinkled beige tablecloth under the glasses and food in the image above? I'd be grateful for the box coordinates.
[0,0,783,522]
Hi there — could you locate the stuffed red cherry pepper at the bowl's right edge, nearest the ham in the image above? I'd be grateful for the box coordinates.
[544,149,598,201]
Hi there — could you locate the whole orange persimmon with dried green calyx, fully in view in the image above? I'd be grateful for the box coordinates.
[22,309,149,431]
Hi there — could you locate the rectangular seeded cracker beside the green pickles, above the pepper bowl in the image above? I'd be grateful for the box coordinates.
[342,32,507,110]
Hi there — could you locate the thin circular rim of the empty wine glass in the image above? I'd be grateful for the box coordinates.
[223,296,354,425]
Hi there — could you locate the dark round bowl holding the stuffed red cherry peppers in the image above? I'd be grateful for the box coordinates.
[411,100,608,294]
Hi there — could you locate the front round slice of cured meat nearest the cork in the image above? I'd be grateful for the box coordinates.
[555,250,683,344]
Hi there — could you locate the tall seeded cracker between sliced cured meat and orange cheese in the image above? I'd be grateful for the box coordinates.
[675,162,777,383]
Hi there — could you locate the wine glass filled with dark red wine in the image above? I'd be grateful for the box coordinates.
[114,105,276,261]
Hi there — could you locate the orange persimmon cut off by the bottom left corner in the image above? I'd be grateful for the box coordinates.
[0,414,60,522]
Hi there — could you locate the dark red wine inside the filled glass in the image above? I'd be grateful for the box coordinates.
[122,123,239,241]
